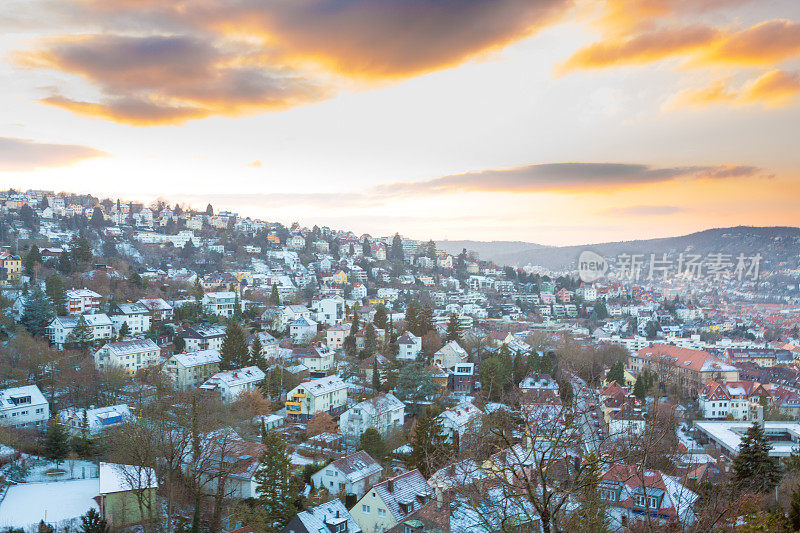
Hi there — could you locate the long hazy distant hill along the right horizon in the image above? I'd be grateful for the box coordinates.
[437,226,800,270]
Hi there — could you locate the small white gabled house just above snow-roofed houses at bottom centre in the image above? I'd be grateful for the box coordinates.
[311,450,383,498]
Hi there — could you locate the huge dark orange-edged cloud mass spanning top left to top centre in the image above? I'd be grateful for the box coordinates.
[16,0,574,126]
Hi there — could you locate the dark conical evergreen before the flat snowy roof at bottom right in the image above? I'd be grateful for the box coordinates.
[732,422,781,492]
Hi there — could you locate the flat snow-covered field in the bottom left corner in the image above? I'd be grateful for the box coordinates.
[0,479,100,529]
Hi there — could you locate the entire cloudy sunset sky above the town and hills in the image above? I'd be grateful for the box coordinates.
[0,0,800,244]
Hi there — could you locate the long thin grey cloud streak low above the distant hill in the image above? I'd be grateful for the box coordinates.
[376,163,760,195]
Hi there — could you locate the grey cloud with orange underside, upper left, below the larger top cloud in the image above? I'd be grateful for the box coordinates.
[20,35,325,125]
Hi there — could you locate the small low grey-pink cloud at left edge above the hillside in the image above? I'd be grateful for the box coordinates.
[0,137,108,172]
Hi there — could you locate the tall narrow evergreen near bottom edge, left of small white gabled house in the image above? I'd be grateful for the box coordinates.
[255,431,297,533]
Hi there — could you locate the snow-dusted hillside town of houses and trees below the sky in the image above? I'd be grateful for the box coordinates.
[0,190,800,533]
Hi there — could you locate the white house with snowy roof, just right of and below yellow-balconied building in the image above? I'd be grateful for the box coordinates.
[339,393,406,446]
